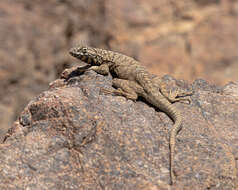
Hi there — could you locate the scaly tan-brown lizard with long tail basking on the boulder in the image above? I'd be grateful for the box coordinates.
[69,46,192,185]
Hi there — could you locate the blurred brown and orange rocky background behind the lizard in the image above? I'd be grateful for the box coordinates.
[0,0,238,135]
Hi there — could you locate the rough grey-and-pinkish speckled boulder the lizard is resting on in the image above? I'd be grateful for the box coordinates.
[0,71,238,190]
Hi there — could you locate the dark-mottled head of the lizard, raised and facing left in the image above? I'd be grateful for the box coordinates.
[69,46,103,65]
